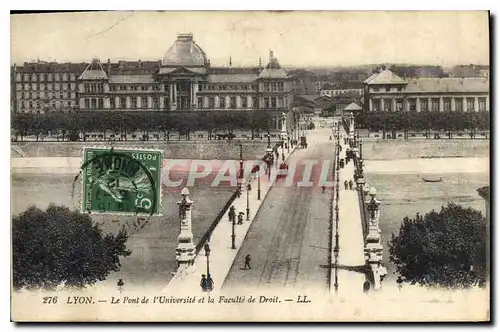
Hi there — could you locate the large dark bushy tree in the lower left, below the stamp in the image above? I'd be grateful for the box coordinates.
[12,205,131,290]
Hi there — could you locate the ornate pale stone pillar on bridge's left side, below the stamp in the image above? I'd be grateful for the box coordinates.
[175,188,196,271]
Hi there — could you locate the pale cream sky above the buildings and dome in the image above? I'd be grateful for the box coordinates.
[11,11,489,67]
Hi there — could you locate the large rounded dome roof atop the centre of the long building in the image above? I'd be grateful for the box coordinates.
[162,33,207,67]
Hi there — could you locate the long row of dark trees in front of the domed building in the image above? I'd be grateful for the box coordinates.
[12,111,274,140]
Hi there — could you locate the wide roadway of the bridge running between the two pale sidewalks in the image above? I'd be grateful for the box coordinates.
[222,128,335,292]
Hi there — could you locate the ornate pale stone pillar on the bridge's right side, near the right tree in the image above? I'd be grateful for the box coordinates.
[365,188,387,290]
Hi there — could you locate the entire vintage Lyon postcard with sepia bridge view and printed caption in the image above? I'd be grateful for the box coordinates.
[10,11,491,322]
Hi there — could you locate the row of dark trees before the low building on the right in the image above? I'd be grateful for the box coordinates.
[355,112,490,138]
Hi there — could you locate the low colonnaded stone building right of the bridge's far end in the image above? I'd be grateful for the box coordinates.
[364,69,490,112]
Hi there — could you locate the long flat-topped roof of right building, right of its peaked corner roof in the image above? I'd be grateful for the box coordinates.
[406,77,490,92]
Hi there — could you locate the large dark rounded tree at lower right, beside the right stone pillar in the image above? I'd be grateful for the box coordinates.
[389,203,487,288]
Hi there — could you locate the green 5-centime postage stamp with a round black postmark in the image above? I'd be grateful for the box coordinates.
[81,147,163,215]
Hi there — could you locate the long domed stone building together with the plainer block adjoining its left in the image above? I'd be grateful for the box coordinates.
[12,34,293,129]
